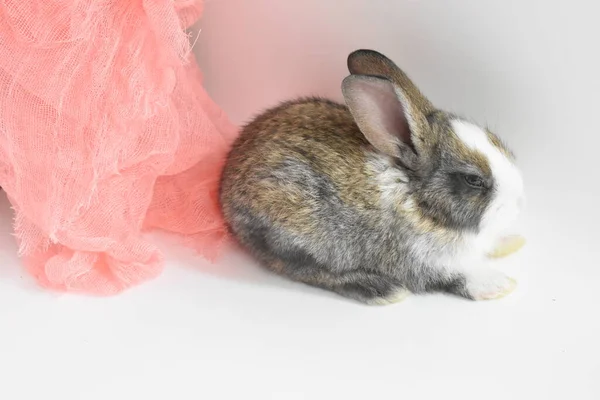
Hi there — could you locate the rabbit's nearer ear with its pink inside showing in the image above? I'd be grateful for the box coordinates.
[342,75,428,168]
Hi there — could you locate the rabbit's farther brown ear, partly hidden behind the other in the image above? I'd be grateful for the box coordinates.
[348,50,435,115]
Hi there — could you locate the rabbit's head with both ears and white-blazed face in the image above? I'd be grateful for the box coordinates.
[342,50,524,238]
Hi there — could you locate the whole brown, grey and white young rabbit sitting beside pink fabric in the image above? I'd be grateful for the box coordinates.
[219,50,525,305]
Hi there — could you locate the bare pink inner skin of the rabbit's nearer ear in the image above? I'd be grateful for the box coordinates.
[357,79,411,144]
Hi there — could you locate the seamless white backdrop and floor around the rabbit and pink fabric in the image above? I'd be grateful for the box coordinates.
[0,0,600,400]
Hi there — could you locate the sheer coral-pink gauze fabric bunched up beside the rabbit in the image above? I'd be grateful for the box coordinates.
[0,0,236,295]
